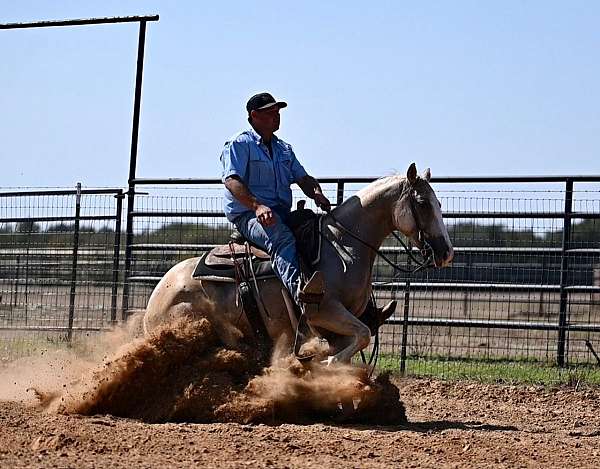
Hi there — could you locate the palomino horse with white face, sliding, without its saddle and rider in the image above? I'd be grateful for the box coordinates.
[143,163,454,363]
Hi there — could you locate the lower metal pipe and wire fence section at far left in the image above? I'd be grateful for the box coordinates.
[0,184,123,360]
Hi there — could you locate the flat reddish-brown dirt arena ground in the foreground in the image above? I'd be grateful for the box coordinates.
[0,379,600,468]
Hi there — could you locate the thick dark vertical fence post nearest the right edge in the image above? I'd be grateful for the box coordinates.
[556,179,573,367]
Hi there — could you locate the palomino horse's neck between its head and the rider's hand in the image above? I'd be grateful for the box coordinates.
[334,176,405,249]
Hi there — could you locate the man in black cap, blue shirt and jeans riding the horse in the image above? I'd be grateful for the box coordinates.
[221,93,396,333]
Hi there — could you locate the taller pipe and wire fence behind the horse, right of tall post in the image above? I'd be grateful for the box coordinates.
[124,176,600,372]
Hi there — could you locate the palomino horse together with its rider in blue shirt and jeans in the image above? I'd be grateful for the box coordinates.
[143,120,454,364]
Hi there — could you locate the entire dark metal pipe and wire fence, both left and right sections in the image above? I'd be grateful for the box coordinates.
[0,176,600,373]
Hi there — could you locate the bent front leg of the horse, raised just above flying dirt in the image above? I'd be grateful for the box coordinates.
[305,298,371,363]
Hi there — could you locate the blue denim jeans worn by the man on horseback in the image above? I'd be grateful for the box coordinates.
[233,208,300,301]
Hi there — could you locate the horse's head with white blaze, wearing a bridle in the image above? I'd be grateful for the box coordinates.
[394,163,454,267]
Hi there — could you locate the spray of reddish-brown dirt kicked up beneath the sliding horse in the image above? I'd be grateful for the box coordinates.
[30,319,406,424]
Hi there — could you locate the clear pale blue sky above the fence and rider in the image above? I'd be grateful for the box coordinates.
[0,0,600,187]
